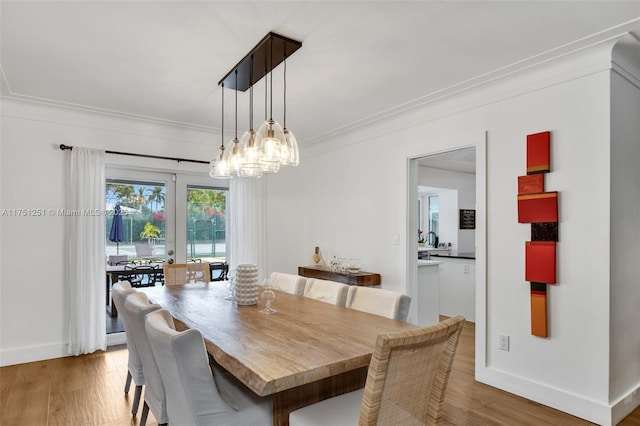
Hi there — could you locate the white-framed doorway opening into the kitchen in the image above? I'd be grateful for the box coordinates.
[406,132,487,378]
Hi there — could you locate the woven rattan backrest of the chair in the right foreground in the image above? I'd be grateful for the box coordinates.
[360,316,464,426]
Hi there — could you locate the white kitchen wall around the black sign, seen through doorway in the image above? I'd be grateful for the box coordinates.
[418,167,476,253]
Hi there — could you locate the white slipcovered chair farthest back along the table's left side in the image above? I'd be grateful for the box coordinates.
[111,281,144,416]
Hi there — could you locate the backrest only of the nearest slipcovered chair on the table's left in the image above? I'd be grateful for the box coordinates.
[145,309,235,426]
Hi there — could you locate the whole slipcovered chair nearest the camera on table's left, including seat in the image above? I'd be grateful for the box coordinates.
[146,309,273,426]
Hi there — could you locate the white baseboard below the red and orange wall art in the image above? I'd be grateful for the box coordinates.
[476,368,612,426]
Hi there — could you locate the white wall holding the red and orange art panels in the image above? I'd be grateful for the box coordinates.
[270,38,637,424]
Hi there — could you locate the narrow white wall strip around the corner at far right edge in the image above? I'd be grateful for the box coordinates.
[601,35,640,421]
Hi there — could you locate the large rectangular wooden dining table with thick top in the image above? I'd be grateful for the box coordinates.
[139,282,418,425]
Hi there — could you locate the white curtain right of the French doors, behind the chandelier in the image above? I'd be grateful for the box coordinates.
[227,177,268,279]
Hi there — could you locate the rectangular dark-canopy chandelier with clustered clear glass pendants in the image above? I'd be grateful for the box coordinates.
[209,32,302,179]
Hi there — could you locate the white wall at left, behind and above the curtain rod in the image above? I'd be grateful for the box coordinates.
[0,99,217,365]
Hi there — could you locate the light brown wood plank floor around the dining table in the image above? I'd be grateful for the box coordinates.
[0,323,640,426]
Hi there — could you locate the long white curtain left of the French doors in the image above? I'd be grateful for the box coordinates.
[66,147,107,355]
